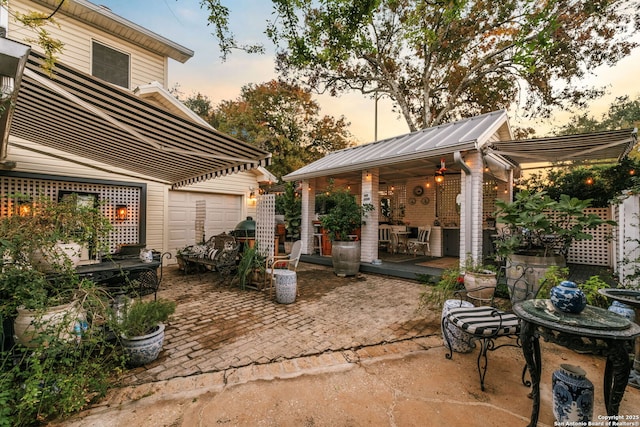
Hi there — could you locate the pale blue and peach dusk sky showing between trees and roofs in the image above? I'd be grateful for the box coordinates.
[100,0,640,143]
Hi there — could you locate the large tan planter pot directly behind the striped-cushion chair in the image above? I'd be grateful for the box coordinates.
[506,254,567,301]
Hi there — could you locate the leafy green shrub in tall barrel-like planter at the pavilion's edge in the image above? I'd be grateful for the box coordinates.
[320,188,374,276]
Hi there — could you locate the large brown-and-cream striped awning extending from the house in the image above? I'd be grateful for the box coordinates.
[11,53,271,188]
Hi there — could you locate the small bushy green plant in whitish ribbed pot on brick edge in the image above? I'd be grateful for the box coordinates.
[112,299,176,366]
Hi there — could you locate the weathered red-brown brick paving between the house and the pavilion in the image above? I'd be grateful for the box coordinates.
[123,263,439,385]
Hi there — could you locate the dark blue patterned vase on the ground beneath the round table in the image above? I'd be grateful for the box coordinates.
[551,364,593,425]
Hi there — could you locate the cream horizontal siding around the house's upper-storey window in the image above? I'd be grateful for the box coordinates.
[8,1,168,89]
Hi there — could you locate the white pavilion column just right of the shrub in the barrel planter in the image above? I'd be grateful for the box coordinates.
[360,169,380,262]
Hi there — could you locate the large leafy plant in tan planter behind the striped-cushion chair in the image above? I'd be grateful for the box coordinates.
[494,190,615,300]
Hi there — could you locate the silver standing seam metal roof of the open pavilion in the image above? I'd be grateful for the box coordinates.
[283,110,508,181]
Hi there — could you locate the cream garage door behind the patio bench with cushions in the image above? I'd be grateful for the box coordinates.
[169,191,244,255]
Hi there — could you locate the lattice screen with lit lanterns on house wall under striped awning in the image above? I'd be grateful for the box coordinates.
[0,176,144,252]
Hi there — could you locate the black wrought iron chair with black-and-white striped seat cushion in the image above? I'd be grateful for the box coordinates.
[442,265,540,391]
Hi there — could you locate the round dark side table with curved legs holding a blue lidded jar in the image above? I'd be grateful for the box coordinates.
[513,299,640,427]
